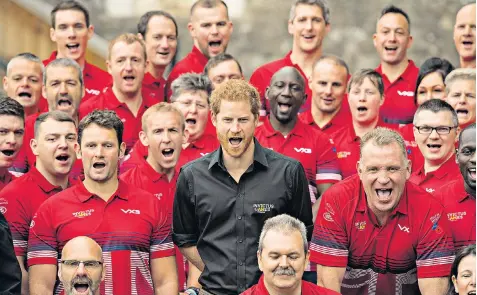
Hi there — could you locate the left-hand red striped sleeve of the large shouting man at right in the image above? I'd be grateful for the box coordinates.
[310,187,349,267]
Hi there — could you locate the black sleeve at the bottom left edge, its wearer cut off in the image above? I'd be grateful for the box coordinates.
[0,213,22,295]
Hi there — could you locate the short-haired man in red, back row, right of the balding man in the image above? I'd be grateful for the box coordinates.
[166,0,233,98]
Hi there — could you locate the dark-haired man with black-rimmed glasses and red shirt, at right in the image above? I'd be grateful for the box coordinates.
[409,99,462,194]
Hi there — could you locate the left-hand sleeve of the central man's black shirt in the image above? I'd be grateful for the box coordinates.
[172,170,199,247]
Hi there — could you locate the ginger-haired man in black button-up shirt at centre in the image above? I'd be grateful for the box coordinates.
[173,80,313,295]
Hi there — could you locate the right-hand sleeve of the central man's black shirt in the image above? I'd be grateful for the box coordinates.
[288,163,313,241]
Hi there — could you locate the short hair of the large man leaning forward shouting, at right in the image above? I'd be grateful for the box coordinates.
[359,127,407,163]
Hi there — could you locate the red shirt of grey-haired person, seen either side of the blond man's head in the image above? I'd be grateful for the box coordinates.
[120,133,220,174]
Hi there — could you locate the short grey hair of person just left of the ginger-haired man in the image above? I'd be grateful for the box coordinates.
[171,73,212,102]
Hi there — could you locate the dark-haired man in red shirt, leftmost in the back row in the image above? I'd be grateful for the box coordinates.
[43,0,111,103]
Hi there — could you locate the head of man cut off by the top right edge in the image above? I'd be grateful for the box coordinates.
[454,3,476,69]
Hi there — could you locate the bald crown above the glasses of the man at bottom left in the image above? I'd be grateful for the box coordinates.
[61,236,103,261]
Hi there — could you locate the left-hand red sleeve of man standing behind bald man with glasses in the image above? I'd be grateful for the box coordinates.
[27,201,58,266]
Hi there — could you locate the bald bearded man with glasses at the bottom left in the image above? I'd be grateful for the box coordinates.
[58,236,106,295]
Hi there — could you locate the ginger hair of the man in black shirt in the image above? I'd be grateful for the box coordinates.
[210,79,260,118]
